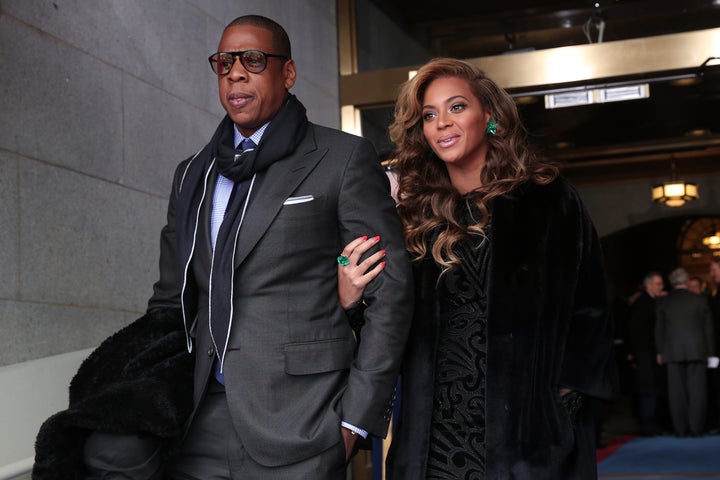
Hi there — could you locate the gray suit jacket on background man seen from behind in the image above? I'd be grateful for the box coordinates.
[655,288,715,363]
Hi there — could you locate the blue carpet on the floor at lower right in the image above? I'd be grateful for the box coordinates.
[598,435,720,480]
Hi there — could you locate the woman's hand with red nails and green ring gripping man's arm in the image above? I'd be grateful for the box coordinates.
[338,236,385,310]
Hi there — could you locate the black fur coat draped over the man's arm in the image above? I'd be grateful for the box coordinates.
[32,309,195,480]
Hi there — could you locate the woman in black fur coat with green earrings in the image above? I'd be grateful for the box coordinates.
[339,59,616,480]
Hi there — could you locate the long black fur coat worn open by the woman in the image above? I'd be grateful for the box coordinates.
[387,178,616,480]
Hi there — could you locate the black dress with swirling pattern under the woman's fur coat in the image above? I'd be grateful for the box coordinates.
[427,205,490,480]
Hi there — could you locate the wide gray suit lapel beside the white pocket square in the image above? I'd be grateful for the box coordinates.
[235,132,328,268]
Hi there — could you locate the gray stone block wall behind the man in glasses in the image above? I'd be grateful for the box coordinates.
[0,0,339,366]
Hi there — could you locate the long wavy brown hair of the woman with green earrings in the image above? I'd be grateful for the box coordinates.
[390,58,558,273]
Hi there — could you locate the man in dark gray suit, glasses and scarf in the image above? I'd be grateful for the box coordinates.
[86,15,413,480]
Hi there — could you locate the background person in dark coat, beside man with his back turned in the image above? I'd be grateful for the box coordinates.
[627,271,664,436]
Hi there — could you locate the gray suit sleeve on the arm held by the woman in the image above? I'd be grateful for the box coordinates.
[338,136,413,437]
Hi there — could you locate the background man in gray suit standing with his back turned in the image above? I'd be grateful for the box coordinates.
[655,268,714,437]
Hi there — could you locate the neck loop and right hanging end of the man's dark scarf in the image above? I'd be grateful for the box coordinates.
[209,94,308,370]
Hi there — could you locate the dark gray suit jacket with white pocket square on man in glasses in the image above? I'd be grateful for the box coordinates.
[150,124,413,466]
